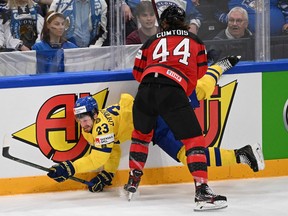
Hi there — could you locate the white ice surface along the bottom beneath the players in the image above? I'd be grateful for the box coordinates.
[0,176,288,216]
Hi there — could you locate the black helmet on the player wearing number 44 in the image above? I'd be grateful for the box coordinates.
[160,5,185,23]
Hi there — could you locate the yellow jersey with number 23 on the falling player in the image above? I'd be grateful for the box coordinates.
[73,94,134,173]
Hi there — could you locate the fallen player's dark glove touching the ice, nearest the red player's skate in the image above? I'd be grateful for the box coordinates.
[88,170,114,193]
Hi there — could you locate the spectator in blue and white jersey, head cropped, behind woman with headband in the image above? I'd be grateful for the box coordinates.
[49,0,107,47]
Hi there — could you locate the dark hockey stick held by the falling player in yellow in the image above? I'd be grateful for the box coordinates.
[2,143,93,186]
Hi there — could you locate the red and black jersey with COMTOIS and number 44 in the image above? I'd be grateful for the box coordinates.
[133,29,208,96]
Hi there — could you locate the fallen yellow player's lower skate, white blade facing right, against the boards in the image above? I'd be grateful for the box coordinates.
[235,143,265,172]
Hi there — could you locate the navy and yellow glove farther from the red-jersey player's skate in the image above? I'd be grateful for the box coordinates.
[47,161,75,182]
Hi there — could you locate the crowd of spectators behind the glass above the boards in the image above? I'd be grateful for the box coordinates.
[0,0,288,60]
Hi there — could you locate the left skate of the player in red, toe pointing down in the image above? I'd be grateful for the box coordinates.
[124,169,143,201]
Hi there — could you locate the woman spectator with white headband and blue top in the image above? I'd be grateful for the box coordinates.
[32,11,77,74]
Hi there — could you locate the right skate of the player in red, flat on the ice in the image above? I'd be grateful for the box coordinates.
[194,184,228,211]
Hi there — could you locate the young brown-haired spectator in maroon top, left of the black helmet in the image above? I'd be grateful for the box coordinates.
[126,1,159,44]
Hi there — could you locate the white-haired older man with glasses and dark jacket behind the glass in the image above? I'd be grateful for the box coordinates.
[209,7,253,61]
